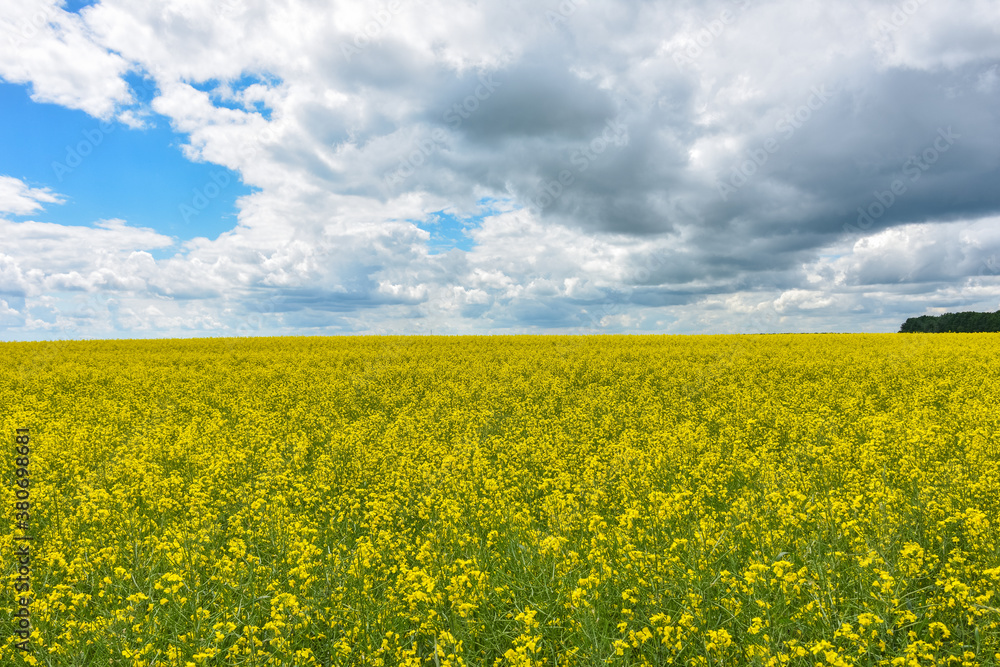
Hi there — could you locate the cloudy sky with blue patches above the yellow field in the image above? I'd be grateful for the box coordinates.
[0,0,1000,341]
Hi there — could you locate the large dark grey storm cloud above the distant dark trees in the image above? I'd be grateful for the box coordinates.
[706,63,1000,240]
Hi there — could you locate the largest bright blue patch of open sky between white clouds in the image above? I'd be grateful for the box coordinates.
[0,78,251,240]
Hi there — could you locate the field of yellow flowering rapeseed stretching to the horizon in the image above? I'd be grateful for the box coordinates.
[0,334,1000,667]
